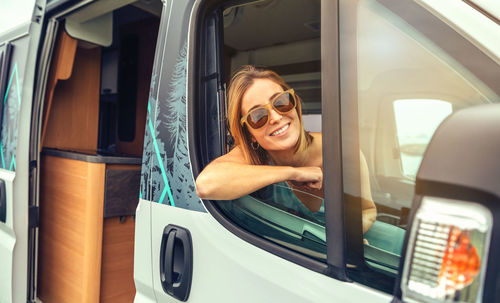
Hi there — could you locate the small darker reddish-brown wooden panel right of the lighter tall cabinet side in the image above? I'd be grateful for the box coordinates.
[101,216,135,303]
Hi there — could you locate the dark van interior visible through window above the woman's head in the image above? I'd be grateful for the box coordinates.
[223,0,321,127]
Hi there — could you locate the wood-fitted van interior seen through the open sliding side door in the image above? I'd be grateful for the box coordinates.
[36,0,162,302]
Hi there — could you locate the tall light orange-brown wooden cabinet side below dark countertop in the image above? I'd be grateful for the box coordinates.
[38,155,105,303]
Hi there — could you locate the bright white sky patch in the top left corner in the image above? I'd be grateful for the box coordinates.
[0,0,35,35]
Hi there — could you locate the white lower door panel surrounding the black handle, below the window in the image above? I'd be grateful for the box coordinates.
[148,203,391,303]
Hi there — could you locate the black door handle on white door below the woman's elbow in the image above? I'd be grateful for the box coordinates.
[160,224,193,301]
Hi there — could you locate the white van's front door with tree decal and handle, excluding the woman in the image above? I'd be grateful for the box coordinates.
[140,0,390,302]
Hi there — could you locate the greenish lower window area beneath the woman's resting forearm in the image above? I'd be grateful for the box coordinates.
[219,184,326,260]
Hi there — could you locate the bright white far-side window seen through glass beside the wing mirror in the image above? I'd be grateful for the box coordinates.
[393,99,453,179]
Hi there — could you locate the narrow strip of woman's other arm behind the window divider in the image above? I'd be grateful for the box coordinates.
[359,151,377,234]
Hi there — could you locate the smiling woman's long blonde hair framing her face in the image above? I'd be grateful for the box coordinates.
[228,65,312,164]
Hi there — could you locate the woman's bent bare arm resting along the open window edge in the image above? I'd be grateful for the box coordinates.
[196,146,323,200]
